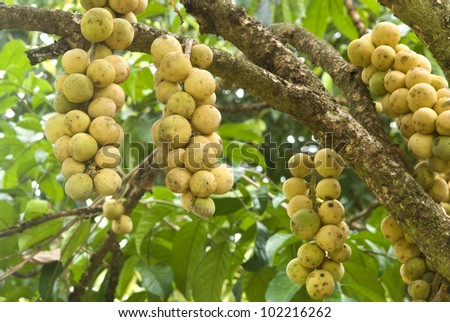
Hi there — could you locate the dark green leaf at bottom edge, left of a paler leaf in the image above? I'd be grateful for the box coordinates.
[242,266,276,302]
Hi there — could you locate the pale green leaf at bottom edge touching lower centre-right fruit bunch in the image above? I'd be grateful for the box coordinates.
[266,269,302,302]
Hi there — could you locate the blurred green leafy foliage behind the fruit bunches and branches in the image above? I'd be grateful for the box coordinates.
[0,0,439,301]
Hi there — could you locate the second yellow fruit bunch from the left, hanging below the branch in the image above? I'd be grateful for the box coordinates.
[150,35,234,218]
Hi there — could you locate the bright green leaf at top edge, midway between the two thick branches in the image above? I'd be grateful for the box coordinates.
[303,0,330,38]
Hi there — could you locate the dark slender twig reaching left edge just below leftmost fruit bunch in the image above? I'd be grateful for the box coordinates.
[0,206,102,238]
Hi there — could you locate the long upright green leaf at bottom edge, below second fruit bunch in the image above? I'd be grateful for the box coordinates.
[192,241,231,302]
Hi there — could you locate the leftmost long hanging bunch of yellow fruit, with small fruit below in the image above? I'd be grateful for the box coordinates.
[45,0,147,233]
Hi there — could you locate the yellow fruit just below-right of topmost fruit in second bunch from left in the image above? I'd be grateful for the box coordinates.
[159,52,192,83]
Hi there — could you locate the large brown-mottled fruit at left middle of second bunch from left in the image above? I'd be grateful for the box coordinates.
[158,115,192,149]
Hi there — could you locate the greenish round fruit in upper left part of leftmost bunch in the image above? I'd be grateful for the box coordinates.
[63,73,94,103]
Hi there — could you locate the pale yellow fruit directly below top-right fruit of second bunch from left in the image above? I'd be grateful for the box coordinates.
[184,68,216,100]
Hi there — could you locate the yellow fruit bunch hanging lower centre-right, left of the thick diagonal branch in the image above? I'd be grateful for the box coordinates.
[283,148,351,300]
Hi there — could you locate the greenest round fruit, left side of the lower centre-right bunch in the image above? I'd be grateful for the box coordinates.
[290,209,321,239]
